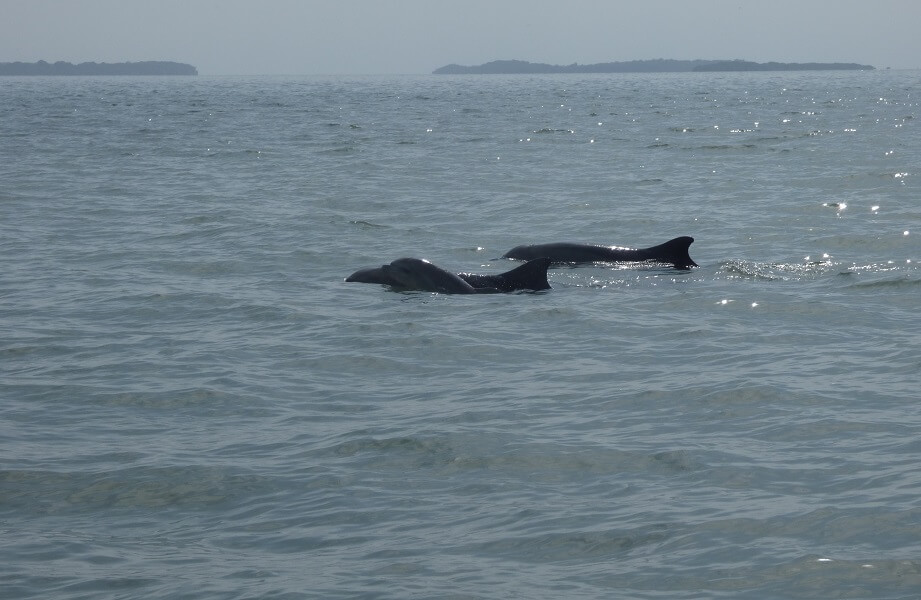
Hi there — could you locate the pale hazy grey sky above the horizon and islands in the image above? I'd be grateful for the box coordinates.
[0,0,921,75]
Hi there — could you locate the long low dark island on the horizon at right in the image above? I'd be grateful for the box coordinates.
[432,58,874,75]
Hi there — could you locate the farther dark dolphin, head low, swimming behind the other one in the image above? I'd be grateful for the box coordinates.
[502,236,697,269]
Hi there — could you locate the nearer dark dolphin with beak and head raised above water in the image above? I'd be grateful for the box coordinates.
[345,257,550,294]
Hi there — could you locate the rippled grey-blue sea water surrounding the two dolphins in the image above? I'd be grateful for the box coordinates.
[0,71,921,599]
